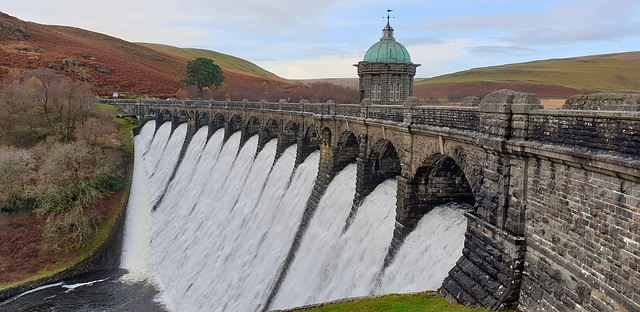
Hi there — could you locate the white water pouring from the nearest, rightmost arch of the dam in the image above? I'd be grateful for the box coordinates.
[376,204,467,294]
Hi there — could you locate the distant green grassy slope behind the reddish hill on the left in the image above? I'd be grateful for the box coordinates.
[136,42,284,81]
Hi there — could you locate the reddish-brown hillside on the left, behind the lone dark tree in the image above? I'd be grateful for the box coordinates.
[0,13,281,97]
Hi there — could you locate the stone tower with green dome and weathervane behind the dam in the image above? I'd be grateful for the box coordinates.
[354,15,420,104]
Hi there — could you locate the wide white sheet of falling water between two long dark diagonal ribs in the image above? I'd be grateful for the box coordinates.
[149,131,319,311]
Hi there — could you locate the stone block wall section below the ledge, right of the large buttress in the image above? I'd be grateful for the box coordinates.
[520,159,640,311]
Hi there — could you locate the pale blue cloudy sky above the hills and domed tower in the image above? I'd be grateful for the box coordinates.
[0,0,640,79]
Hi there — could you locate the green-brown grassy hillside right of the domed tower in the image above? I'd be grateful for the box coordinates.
[414,52,640,98]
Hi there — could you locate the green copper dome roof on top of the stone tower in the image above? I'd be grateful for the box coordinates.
[364,23,411,63]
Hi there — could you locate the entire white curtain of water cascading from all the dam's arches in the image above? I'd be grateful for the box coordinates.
[122,124,466,311]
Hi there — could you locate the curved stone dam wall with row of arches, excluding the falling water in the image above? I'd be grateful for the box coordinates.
[104,90,640,311]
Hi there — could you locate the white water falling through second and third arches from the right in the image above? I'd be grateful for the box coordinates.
[273,176,396,309]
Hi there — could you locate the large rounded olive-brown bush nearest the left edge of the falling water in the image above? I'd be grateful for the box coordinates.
[36,141,125,248]
